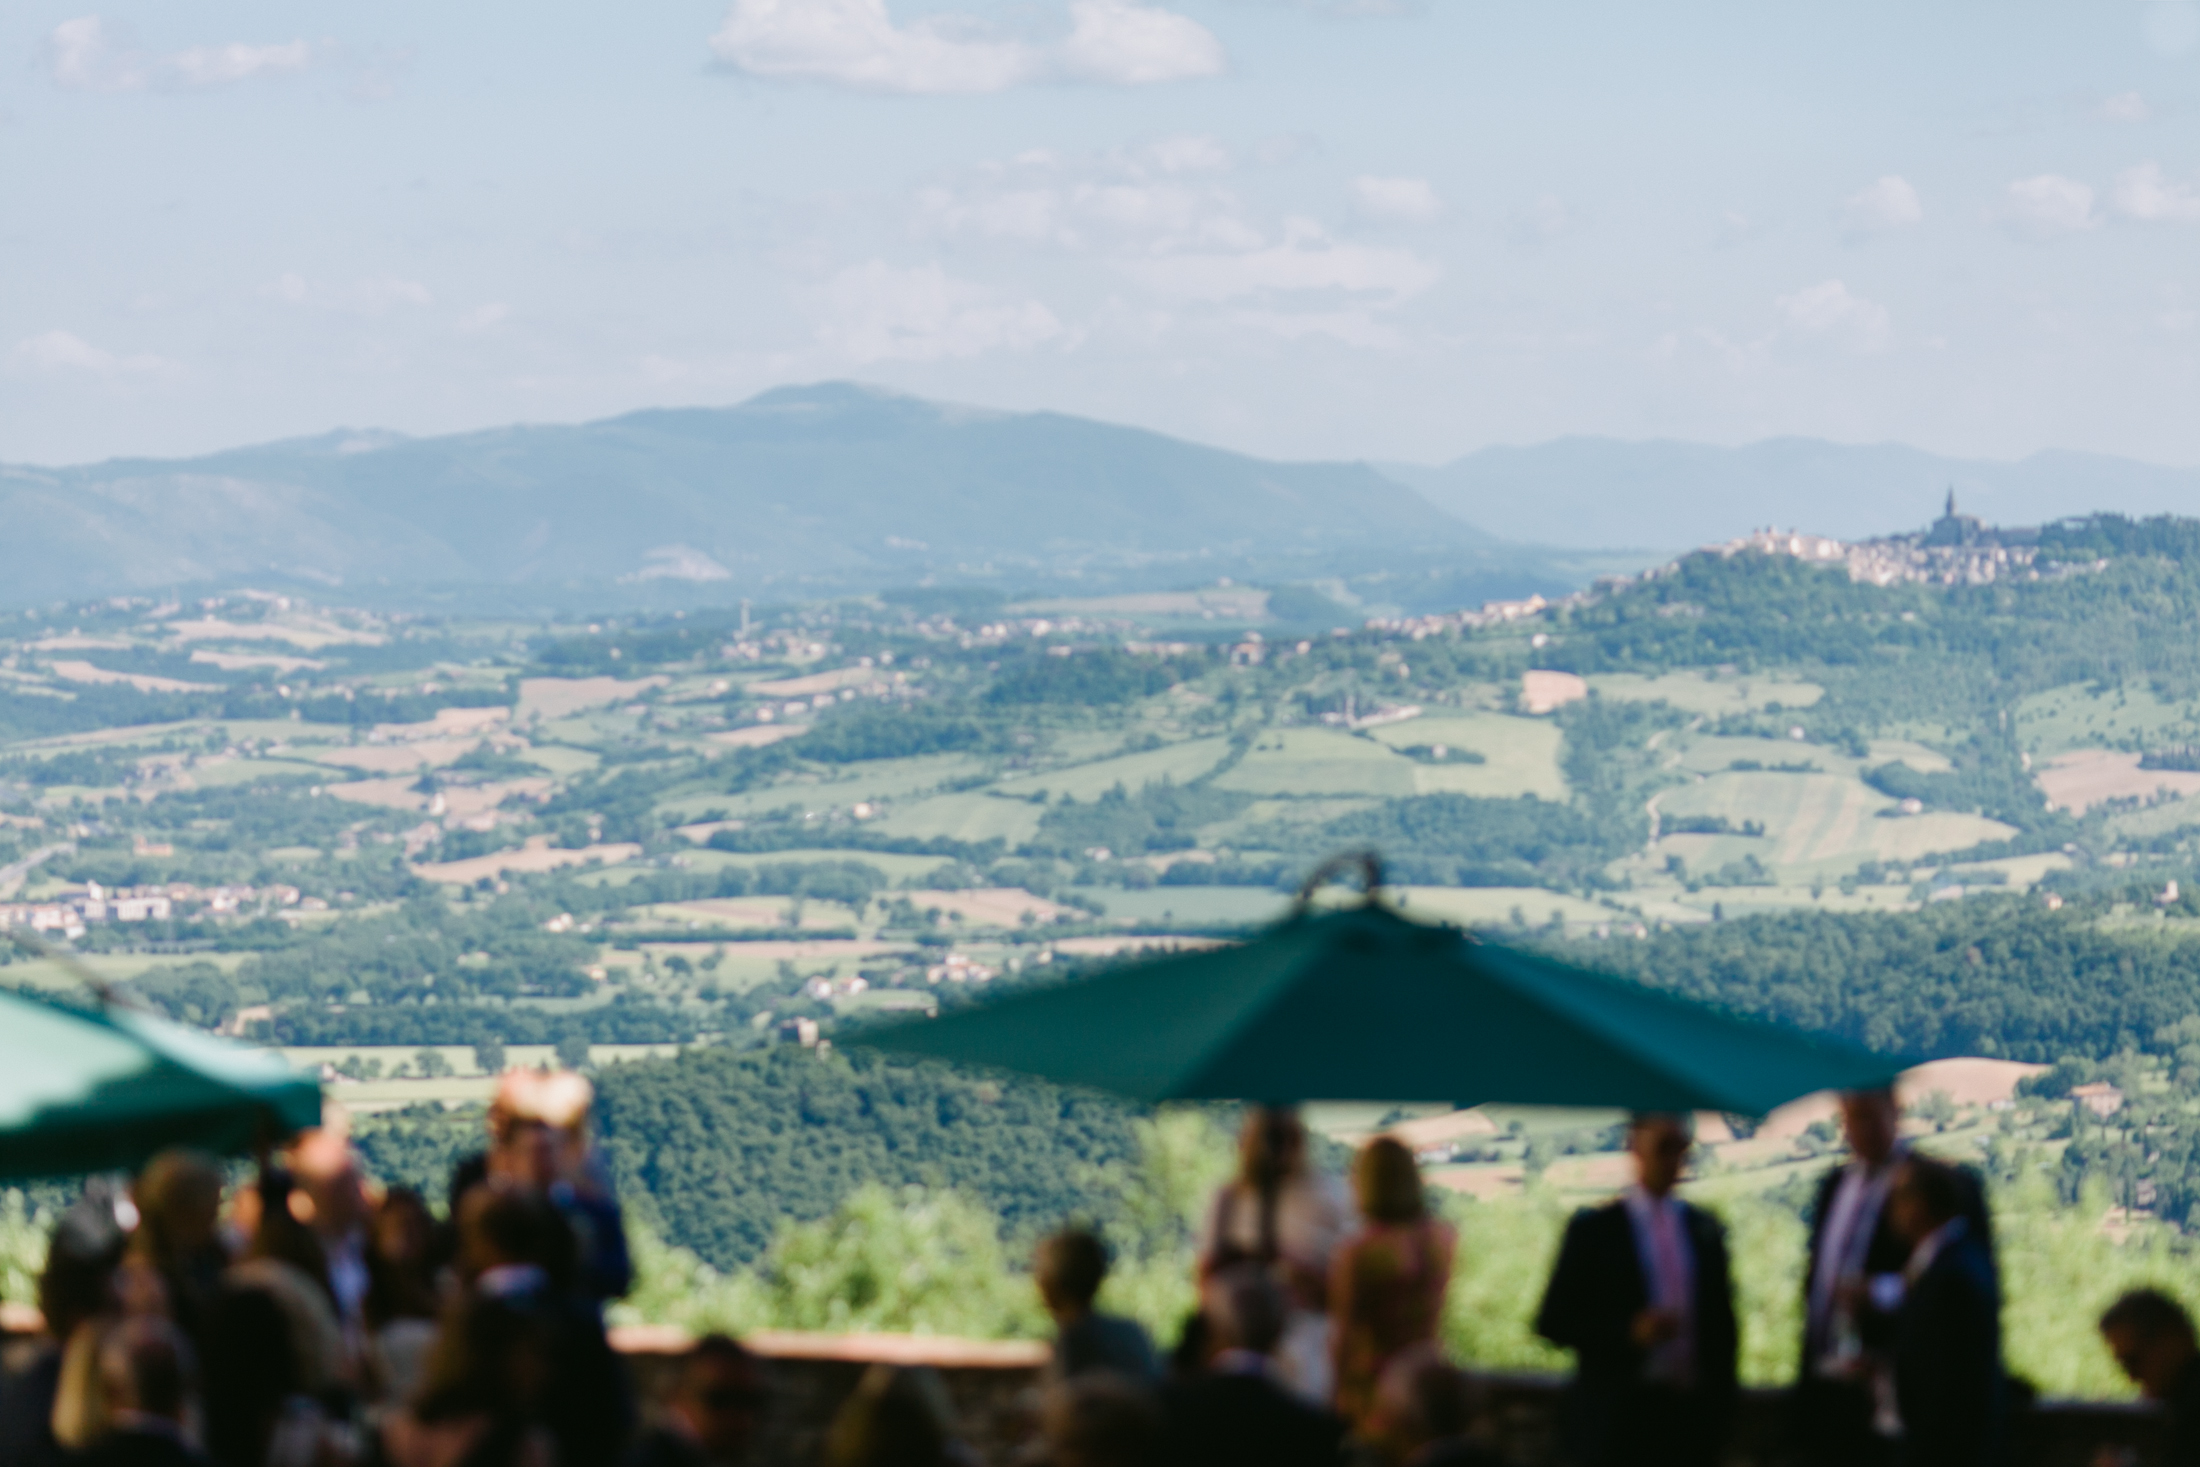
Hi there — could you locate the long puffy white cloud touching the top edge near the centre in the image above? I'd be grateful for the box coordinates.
[711,0,1228,95]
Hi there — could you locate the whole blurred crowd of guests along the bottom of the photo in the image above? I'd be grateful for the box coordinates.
[0,1071,2200,1467]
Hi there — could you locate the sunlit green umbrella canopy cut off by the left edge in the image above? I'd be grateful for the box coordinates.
[0,990,321,1181]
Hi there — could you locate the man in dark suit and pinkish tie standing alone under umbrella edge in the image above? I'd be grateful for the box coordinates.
[1536,1115,1738,1467]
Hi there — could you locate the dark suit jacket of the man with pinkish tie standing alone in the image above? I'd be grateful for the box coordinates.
[1536,1201,1740,1460]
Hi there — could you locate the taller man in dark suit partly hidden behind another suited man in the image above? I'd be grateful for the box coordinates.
[1791,1089,1993,1467]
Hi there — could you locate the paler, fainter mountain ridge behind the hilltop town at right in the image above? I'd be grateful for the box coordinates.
[1382,438,2200,550]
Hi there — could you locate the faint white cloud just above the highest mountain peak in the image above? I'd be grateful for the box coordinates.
[816,260,1067,363]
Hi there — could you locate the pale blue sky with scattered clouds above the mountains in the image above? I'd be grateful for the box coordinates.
[0,0,2200,464]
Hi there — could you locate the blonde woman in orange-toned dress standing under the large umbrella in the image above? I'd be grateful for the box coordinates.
[1329,1135,1459,1427]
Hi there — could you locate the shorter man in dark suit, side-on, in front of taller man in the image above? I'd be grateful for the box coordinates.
[1888,1157,2009,1467]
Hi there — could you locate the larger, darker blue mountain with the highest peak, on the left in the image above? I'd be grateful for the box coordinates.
[0,385,1522,615]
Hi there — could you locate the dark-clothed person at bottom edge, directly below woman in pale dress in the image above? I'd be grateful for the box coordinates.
[1162,1262,1344,1467]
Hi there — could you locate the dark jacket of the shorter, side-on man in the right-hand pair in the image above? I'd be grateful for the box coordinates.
[1894,1225,2009,1467]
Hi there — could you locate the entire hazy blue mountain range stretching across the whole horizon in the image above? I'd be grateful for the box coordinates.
[0,383,2200,611]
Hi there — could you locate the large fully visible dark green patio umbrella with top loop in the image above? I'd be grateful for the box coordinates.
[849,858,1910,1115]
